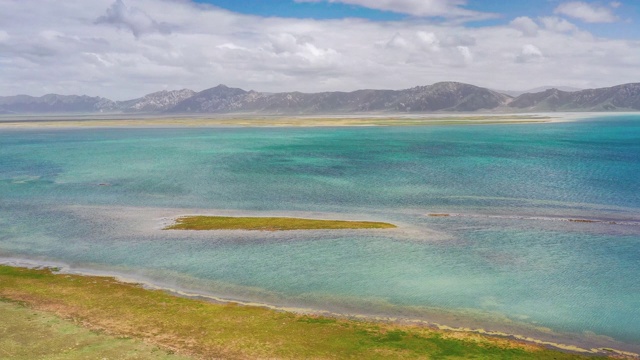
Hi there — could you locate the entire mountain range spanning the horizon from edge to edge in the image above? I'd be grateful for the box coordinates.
[0,82,640,115]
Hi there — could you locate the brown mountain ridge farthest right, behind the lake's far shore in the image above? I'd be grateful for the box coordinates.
[509,83,640,111]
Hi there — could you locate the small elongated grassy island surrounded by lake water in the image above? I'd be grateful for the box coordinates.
[165,216,396,231]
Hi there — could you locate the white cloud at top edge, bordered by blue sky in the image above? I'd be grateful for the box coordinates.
[296,0,495,20]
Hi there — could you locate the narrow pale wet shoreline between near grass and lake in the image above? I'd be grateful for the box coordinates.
[0,257,640,359]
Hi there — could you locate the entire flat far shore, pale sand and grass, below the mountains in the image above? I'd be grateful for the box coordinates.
[0,112,638,130]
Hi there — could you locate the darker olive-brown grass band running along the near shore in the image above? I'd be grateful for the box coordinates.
[0,266,608,360]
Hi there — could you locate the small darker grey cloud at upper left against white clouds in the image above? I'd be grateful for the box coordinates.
[96,0,171,37]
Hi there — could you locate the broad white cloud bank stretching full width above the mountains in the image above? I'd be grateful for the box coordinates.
[0,0,640,100]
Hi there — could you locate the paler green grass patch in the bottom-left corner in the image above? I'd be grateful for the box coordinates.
[0,301,188,360]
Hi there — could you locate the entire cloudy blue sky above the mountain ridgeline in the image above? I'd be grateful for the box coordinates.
[0,0,640,100]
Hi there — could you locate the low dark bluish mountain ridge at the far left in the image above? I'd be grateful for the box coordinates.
[0,94,117,113]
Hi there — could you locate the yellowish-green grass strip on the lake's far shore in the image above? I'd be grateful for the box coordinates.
[0,115,558,128]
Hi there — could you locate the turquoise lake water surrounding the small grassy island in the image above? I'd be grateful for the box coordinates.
[0,116,640,349]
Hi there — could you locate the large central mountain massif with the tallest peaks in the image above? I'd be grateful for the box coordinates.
[169,82,509,114]
